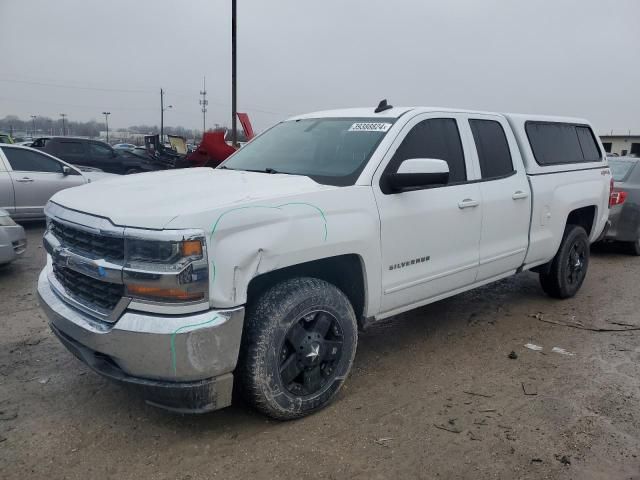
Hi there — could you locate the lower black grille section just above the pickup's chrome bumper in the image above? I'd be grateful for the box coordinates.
[53,263,124,311]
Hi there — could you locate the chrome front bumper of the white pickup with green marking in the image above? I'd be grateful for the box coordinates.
[38,266,244,413]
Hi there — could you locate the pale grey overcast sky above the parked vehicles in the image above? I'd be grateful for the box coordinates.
[0,0,640,133]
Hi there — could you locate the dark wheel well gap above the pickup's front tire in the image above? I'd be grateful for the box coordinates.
[247,254,365,319]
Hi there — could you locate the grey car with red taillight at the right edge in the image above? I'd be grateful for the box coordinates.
[605,157,640,255]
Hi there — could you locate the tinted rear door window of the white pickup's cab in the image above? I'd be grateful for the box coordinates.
[469,120,513,179]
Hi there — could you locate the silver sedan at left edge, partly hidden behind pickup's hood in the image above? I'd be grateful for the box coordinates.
[0,144,114,220]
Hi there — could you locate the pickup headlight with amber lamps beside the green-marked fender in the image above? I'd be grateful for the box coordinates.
[123,237,209,304]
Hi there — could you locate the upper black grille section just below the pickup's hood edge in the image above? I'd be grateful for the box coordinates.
[51,220,124,261]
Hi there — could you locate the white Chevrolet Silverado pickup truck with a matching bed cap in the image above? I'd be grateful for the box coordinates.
[38,101,611,419]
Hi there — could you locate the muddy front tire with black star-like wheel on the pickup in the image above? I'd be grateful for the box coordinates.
[239,277,358,420]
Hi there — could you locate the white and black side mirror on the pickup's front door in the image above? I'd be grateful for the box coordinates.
[387,158,449,192]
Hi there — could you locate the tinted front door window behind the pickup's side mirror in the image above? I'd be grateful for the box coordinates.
[388,118,467,183]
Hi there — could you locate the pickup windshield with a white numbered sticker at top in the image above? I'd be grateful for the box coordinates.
[222,118,395,185]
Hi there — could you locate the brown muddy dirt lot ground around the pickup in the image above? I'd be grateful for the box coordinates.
[0,225,640,480]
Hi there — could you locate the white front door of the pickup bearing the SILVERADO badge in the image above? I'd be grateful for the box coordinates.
[374,114,482,313]
